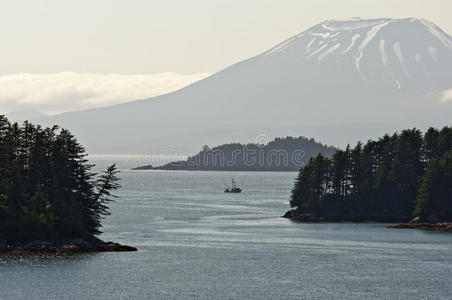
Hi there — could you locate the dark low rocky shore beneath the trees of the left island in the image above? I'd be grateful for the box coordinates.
[0,238,137,254]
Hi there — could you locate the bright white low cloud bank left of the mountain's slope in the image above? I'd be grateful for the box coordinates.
[0,72,209,115]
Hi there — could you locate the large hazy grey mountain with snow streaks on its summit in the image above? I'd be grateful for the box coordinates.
[38,18,452,153]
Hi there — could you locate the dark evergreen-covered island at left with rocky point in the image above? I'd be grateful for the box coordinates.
[0,115,136,253]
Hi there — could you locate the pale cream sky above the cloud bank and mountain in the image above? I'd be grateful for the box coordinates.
[0,0,452,111]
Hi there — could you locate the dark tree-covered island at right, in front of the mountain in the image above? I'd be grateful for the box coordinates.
[285,127,452,231]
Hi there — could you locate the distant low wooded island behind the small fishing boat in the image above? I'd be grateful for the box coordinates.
[134,137,336,171]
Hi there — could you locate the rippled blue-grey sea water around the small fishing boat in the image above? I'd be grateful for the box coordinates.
[0,158,452,299]
